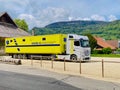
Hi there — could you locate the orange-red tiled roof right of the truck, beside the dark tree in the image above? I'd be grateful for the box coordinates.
[94,36,116,50]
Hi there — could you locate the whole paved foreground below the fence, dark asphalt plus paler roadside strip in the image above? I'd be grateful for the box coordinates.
[0,64,120,90]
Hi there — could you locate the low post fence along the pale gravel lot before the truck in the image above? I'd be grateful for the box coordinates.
[21,57,120,78]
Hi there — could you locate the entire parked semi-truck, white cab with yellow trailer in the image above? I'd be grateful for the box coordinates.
[5,34,90,60]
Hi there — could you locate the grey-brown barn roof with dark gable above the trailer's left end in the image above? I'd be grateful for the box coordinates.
[0,12,30,37]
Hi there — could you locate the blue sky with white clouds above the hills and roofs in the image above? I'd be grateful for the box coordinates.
[0,0,120,29]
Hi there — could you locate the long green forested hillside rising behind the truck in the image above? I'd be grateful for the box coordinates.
[33,20,120,39]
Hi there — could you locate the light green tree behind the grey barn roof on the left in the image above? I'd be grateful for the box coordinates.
[14,19,28,31]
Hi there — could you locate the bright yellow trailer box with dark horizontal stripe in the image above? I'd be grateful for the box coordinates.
[5,34,67,54]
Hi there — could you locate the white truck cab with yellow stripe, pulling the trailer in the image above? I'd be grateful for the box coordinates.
[58,34,91,60]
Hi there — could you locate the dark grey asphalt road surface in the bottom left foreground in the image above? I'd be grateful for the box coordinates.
[0,71,82,90]
